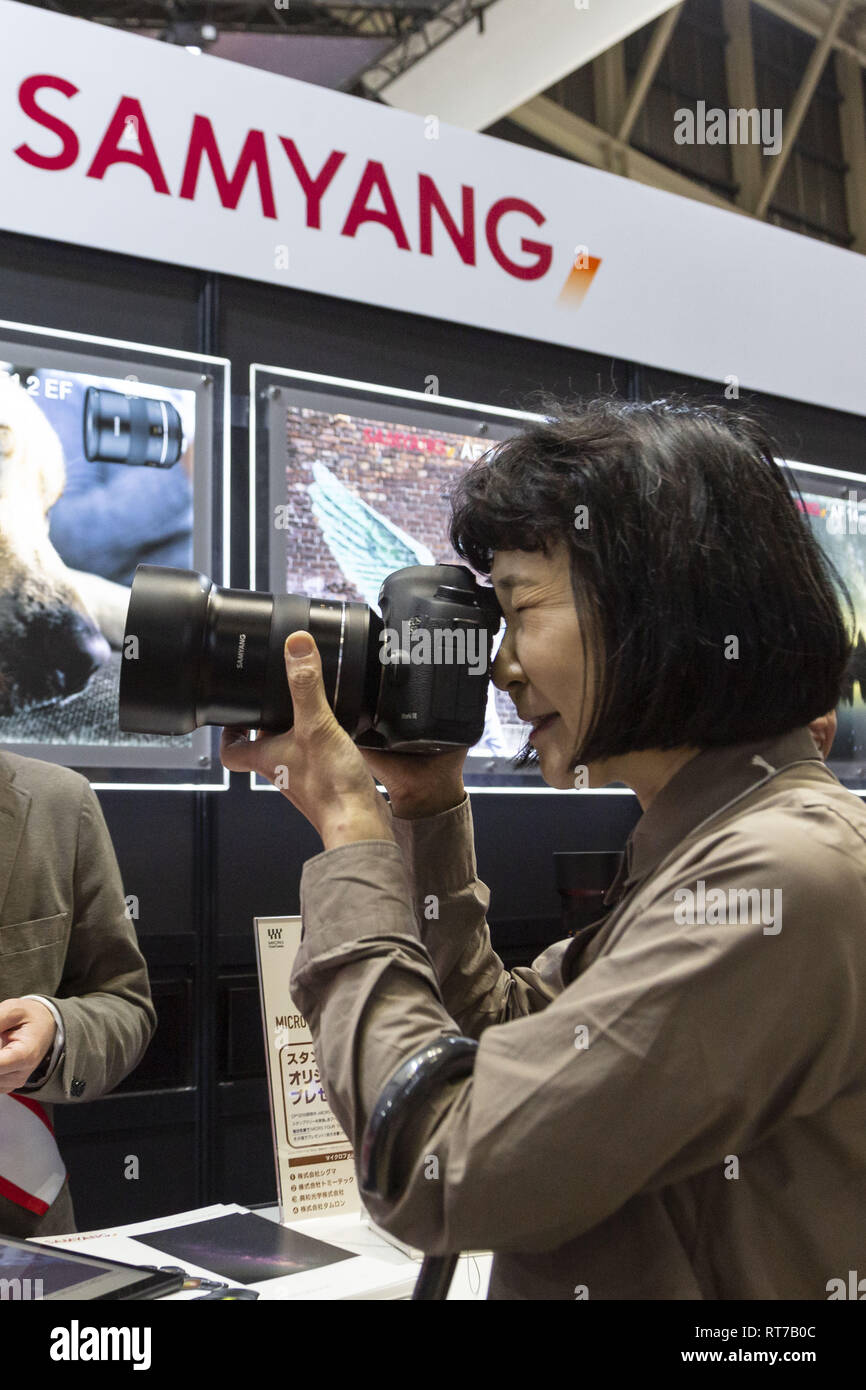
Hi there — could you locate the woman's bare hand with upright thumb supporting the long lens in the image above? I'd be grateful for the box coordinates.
[220,631,393,849]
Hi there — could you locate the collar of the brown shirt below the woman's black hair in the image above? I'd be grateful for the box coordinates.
[603,726,833,906]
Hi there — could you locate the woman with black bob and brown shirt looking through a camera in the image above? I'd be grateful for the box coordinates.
[224,402,866,1298]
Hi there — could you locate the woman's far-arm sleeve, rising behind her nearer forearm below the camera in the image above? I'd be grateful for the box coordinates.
[392,796,557,1038]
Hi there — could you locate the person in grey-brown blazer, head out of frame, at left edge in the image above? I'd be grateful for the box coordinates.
[0,751,156,1237]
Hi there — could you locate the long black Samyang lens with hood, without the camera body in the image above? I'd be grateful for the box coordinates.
[120,564,382,735]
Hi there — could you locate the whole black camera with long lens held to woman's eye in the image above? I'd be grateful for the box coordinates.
[120,564,500,752]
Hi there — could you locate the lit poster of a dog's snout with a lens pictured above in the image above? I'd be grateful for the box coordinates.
[0,360,195,746]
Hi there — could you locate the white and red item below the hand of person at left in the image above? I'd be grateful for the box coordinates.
[0,1095,67,1216]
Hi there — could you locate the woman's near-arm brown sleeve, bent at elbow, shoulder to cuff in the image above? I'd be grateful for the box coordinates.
[292,833,866,1254]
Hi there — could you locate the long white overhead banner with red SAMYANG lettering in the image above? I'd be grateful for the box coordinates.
[0,0,866,414]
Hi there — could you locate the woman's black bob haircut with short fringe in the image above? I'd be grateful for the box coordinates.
[450,395,853,765]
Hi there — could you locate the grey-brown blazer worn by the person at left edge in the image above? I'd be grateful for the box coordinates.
[0,751,156,1234]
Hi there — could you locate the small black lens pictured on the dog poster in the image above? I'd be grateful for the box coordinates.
[83,386,183,468]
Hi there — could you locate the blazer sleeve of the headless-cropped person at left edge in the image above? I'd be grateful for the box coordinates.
[33,780,156,1104]
